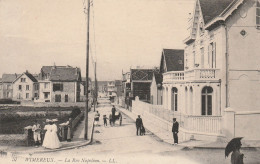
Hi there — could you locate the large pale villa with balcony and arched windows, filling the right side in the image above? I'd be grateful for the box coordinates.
[161,0,260,140]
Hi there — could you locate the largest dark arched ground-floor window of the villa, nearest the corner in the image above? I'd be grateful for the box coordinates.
[201,87,213,115]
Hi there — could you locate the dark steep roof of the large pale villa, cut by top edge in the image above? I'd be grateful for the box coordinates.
[199,0,238,24]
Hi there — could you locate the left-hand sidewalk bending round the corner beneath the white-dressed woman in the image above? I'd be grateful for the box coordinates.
[0,111,95,154]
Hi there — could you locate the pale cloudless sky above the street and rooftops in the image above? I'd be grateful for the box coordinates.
[0,0,194,80]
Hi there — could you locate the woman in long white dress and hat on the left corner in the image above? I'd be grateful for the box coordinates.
[42,120,61,149]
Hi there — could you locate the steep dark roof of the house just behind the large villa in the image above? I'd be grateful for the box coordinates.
[160,49,184,73]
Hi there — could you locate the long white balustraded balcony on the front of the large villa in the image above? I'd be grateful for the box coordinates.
[163,68,220,83]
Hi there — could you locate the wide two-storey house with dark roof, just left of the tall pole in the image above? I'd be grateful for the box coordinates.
[38,66,81,102]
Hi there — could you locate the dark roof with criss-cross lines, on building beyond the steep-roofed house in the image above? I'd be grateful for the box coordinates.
[131,69,159,81]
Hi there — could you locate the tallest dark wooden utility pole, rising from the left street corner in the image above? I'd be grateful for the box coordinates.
[84,0,90,140]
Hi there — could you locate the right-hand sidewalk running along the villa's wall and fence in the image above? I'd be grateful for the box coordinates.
[116,105,260,149]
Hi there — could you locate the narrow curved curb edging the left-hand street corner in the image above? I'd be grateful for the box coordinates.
[7,121,95,154]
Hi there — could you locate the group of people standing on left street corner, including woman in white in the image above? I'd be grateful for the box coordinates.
[32,118,72,149]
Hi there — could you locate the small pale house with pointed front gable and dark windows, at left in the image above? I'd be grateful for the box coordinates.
[13,71,39,100]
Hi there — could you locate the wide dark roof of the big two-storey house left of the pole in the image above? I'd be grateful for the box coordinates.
[50,67,81,81]
